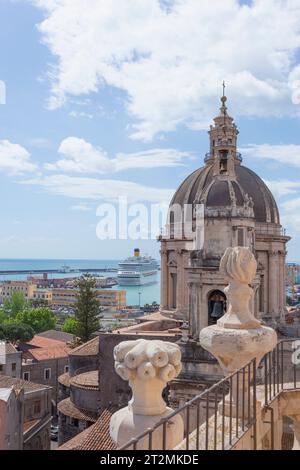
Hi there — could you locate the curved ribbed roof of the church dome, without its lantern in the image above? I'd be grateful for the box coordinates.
[171,164,280,224]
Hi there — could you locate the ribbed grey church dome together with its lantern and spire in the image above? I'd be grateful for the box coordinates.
[171,92,280,224]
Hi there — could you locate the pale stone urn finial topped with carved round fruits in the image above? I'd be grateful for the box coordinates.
[110,339,184,450]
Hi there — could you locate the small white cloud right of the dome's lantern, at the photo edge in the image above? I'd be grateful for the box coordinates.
[241,144,300,168]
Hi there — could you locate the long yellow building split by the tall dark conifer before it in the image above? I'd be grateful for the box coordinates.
[52,288,126,310]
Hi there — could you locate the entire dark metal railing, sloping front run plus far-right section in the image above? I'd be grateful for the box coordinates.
[120,339,300,450]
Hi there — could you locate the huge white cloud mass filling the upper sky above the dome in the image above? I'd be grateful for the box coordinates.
[31,0,300,140]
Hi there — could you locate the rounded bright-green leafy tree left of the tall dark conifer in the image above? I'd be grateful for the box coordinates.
[16,308,56,333]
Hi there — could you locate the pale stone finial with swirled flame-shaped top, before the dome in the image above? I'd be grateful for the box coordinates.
[200,247,277,415]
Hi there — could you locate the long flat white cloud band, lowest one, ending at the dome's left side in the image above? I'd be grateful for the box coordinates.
[21,175,174,203]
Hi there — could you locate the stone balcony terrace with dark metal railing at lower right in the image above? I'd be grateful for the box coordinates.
[120,339,300,450]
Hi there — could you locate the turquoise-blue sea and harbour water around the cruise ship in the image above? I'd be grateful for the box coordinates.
[0,259,160,305]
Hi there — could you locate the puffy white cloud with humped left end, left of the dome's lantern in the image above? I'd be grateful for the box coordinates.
[45,137,191,174]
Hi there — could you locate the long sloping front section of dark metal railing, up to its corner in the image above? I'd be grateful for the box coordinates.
[120,359,256,450]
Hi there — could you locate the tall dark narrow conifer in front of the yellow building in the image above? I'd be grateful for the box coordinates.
[74,274,101,342]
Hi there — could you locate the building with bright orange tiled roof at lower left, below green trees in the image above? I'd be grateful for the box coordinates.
[20,335,71,408]
